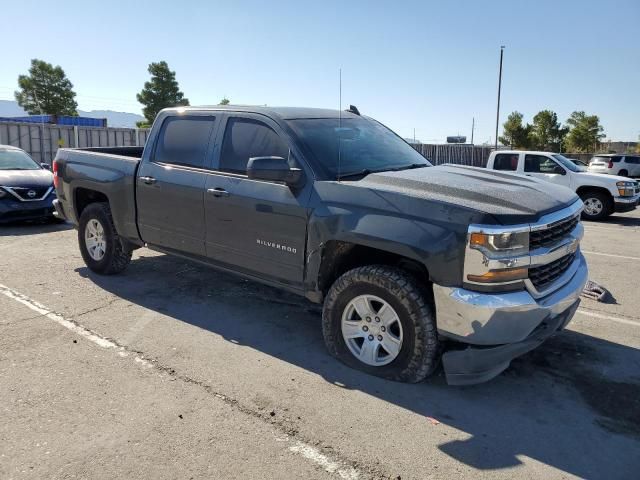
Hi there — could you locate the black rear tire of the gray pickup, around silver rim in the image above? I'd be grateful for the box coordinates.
[78,202,131,275]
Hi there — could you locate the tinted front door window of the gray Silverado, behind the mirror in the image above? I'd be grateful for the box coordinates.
[220,118,289,175]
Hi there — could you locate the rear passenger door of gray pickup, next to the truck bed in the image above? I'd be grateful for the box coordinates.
[136,115,217,256]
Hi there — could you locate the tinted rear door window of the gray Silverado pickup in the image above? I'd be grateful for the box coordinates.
[154,117,215,168]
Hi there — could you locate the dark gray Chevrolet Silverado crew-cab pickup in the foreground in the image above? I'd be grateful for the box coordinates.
[53,107,587,385]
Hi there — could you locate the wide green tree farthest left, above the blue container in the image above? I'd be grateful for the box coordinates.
[14,58,78,115]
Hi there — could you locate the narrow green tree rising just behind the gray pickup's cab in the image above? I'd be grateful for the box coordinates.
[136,61,189,125]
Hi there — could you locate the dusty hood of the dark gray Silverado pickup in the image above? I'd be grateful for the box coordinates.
[357,165,578,224]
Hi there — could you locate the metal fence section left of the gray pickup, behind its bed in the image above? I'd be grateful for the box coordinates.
[0,121,149,164]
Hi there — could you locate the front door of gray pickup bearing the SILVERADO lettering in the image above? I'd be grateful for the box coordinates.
[205,113,311,288]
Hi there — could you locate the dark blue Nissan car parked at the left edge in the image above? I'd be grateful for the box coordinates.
[0,145,56,223]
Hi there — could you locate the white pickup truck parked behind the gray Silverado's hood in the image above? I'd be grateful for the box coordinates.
[487,150,640,220]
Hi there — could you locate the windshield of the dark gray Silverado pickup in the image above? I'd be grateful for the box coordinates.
[287,118,431,180]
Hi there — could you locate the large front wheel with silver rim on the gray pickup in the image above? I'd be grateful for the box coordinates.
[322,265,440,383]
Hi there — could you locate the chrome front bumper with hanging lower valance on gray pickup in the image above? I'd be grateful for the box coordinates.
[434,251,588,385]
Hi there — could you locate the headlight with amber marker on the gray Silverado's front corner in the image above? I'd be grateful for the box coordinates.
[464,225,530,291]
